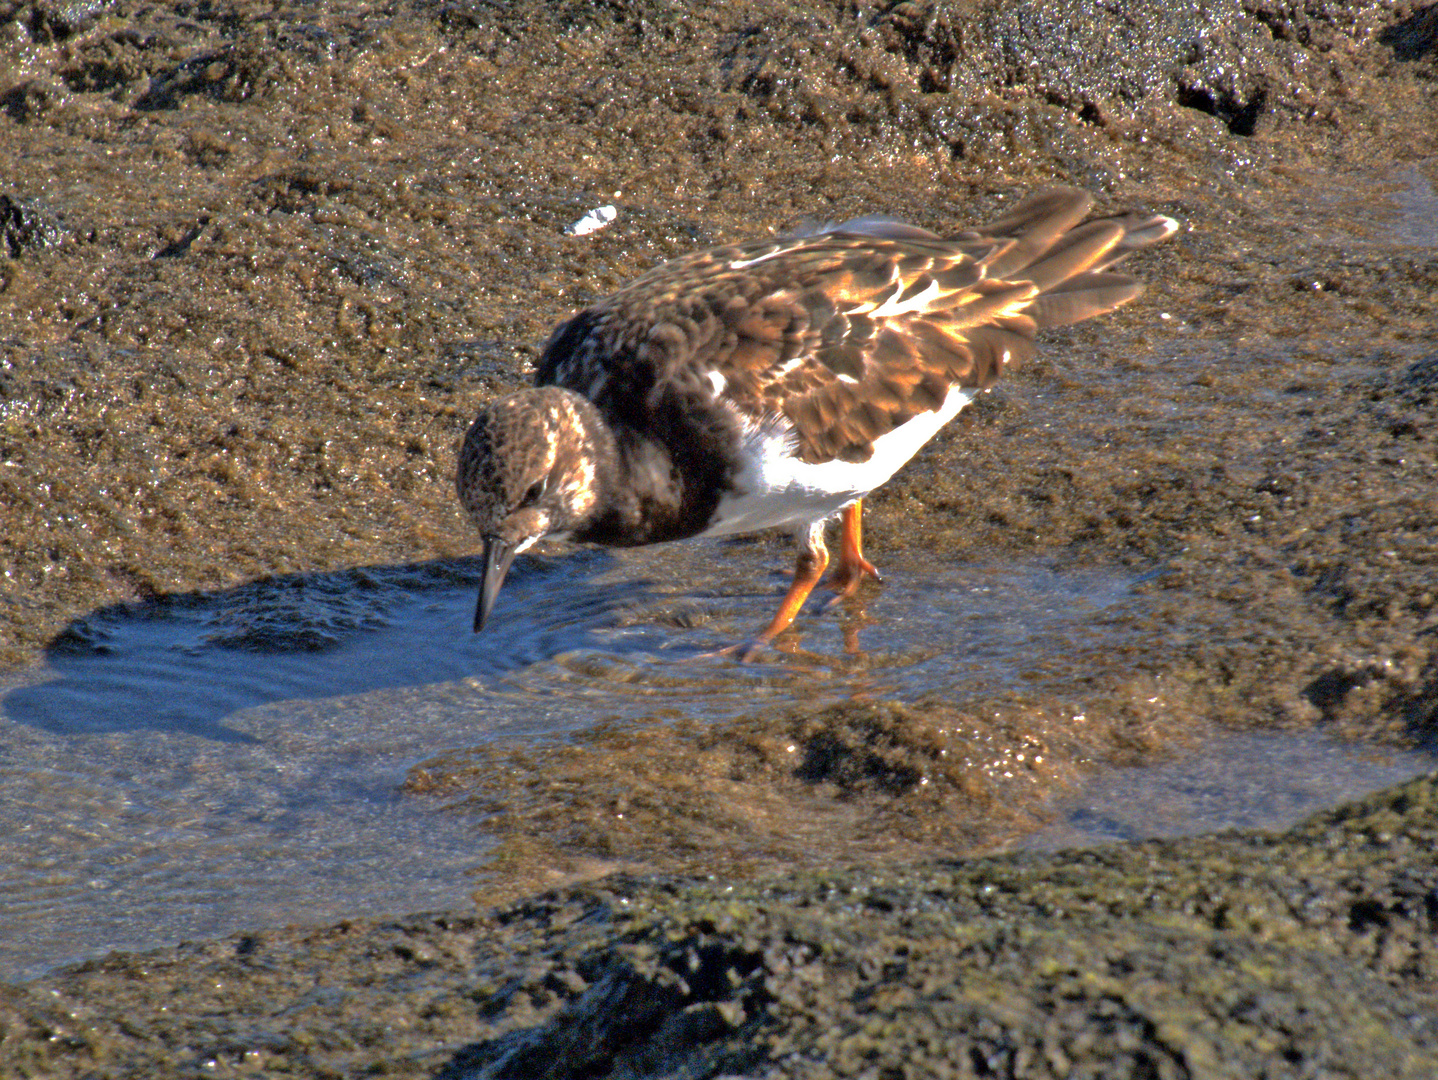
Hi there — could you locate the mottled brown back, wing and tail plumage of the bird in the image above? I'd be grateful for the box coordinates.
[536,188,1172,465]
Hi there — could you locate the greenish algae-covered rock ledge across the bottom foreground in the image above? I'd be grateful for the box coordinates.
[0,775,1438,1080]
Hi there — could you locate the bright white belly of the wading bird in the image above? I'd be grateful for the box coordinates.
[703,387,975,536]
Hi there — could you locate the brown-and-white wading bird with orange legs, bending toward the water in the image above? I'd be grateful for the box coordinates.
[457,188,1178,656]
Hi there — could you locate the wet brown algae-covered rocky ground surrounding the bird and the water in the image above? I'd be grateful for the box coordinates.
[0,3,1438,1076]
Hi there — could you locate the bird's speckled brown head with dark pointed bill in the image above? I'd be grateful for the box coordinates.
[456,387,598,631]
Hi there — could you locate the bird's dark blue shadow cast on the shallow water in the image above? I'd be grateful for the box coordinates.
[0,551,658,742]
